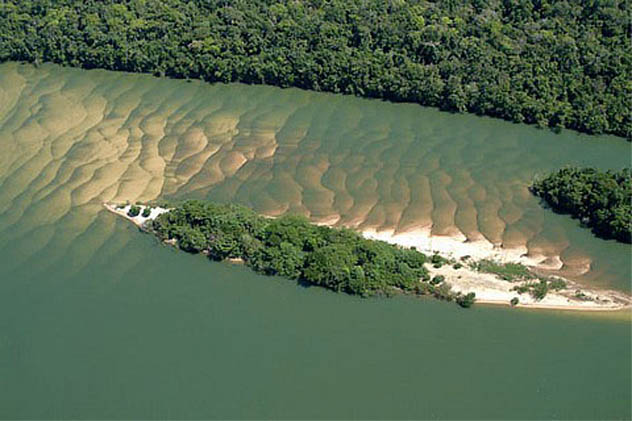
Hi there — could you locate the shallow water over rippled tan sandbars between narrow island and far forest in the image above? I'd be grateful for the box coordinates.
[0,63,630,289]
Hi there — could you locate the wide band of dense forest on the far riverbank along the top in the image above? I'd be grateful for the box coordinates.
[0,0,632,139]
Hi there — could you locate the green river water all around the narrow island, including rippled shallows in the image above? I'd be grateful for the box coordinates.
[0,64,632,419]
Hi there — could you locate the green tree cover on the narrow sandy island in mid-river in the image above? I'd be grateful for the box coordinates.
[149,201,474,307]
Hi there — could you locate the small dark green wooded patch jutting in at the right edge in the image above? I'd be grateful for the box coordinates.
[531,167,632,243]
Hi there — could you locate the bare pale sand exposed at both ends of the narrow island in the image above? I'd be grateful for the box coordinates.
[104,203,632,311]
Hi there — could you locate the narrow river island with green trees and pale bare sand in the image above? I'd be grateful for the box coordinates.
[105,200,631,310]
